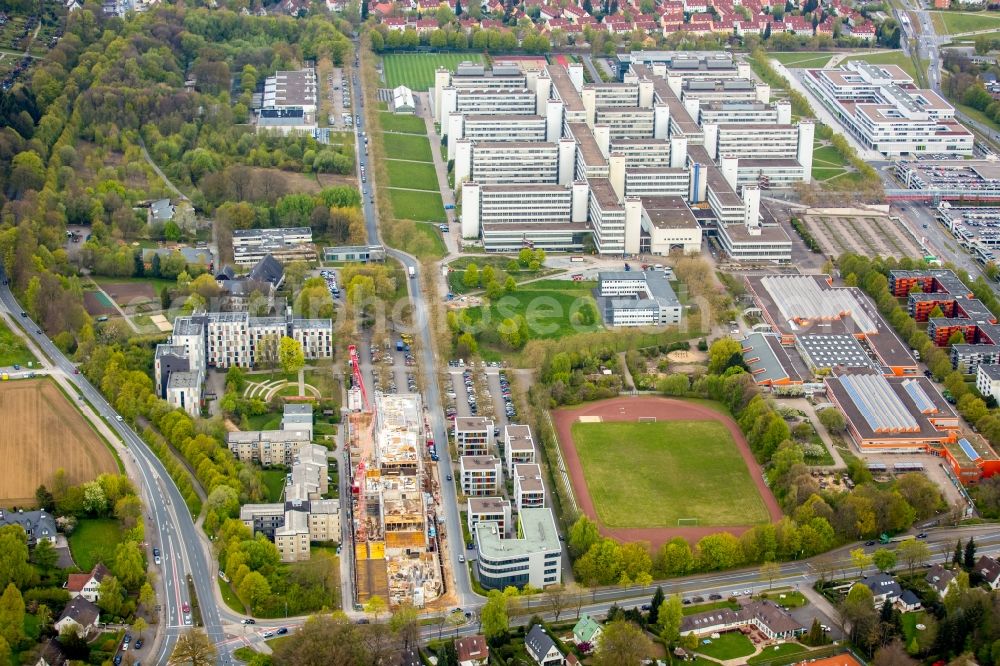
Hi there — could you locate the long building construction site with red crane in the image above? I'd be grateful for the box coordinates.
[348,345,444,608]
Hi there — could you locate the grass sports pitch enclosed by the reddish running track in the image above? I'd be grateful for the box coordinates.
[572,421,768,528]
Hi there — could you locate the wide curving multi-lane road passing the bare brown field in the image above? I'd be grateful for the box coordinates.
[0,273,234,664]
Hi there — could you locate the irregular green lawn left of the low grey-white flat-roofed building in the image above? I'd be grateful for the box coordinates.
[468,280,602,339]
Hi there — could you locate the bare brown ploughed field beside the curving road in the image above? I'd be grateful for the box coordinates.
[0,379,118,506]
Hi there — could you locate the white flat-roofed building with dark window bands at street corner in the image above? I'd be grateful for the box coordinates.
[473,509,562,590]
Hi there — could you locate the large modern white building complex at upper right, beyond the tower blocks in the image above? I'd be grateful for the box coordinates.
[802,61,973,157]
